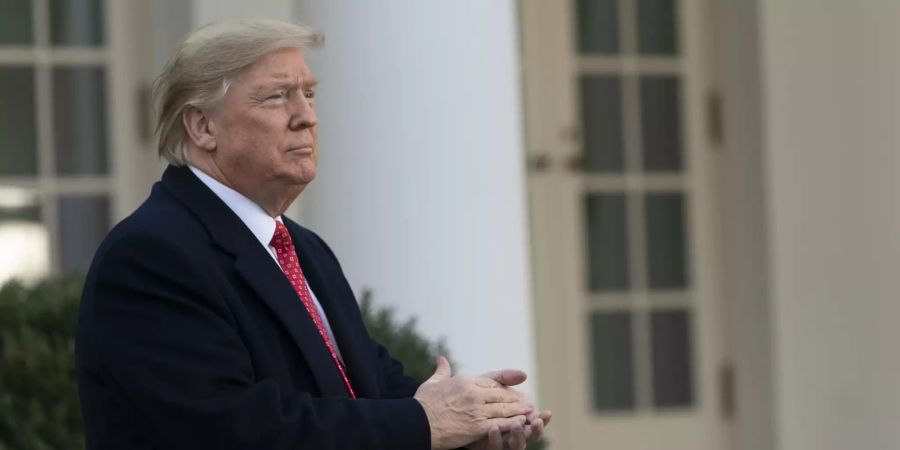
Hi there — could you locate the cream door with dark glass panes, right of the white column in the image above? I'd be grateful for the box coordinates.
[522,0,727,450]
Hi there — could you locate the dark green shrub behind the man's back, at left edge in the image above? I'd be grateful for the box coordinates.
[0,277,84,450]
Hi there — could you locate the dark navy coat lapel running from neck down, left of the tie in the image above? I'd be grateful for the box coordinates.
[162,166,347,397]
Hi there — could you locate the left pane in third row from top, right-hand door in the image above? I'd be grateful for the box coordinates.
[585,194,631,292]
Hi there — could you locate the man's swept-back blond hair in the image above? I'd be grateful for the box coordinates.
[153,19,325,166]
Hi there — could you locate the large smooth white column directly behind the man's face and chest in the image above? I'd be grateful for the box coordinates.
[294,0,534,390]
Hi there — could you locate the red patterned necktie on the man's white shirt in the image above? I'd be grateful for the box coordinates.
[269,220,356,398]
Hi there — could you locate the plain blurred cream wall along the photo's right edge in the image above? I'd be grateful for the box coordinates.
[760,0,900,450]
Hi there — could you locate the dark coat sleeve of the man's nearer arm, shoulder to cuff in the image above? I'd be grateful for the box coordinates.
[79,233,431,450]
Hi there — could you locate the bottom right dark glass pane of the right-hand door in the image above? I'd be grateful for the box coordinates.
[650,311,694,408]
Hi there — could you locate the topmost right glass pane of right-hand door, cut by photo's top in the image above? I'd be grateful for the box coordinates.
[637,0,678,55]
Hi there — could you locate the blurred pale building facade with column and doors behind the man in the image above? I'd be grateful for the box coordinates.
[0,0,900,450]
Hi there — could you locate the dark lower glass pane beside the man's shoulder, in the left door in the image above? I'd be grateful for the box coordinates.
[58,195,110,273]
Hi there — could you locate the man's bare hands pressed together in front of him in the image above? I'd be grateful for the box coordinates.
[413,357,551,450]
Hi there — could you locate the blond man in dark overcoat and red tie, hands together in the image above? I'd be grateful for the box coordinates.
[76,20,550,449]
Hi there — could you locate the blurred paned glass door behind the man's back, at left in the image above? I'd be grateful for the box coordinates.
[0,0,156,283]
